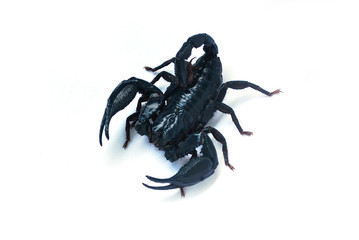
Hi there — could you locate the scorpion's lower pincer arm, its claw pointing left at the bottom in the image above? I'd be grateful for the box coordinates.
[143,131,218,196]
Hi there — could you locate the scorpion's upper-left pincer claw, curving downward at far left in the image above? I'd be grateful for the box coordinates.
[99,77,163,145]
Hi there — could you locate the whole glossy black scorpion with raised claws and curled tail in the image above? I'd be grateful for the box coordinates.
[99,33,280,197]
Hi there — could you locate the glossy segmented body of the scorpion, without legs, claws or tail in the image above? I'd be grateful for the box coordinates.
[151,57,222,148]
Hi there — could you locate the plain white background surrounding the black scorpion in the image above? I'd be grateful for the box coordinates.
[0,0,359,239]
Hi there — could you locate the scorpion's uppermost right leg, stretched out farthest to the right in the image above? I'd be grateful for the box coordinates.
[216,81,281,102]
